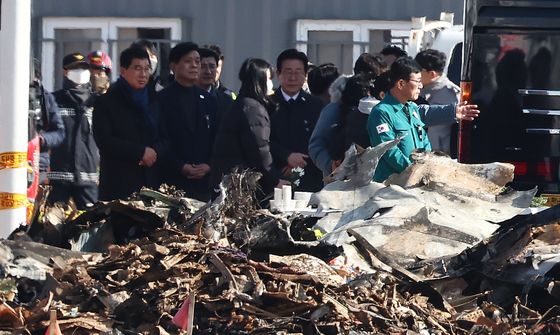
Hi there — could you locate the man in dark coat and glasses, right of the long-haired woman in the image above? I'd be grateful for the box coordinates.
[270,49,323,192]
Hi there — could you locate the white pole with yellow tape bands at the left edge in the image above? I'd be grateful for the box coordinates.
[0,0,31,238]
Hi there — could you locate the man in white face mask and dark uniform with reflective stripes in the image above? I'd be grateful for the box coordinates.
[47,52,99,209]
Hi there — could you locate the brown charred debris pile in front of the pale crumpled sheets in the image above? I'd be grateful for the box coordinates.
[4,224,560,334]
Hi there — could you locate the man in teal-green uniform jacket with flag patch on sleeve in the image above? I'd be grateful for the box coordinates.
[367,57,432,182]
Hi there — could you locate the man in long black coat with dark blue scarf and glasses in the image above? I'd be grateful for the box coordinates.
[93,47,167,200]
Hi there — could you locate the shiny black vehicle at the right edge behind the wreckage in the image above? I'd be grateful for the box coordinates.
[459,0,560,193]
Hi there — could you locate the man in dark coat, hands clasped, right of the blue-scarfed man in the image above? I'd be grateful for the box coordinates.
[158,42,218,201]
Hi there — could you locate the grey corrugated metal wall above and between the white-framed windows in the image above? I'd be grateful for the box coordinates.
[33,0,463,88]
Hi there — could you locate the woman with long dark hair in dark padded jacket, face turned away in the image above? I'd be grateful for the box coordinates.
[211,58,287,200]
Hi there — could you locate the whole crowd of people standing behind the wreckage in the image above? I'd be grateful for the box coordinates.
[30,40,478,209]
